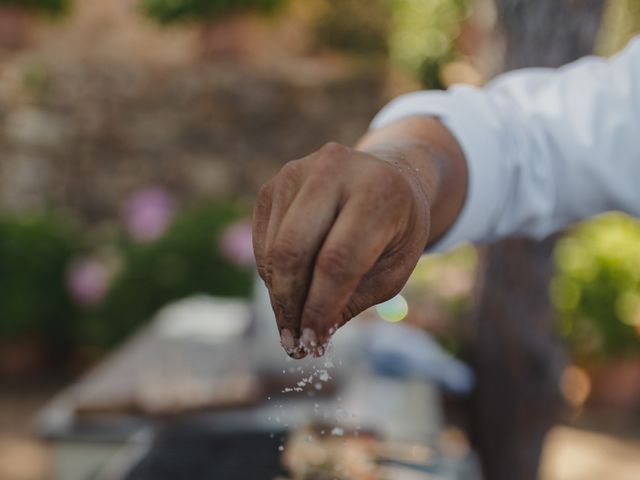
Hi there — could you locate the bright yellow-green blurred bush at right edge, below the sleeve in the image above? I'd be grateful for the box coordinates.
[550,214,640,361]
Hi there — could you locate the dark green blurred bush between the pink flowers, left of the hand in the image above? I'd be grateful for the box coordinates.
[81,204,253,347]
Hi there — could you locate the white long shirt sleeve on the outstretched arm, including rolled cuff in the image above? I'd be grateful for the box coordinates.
[372,37,640,251]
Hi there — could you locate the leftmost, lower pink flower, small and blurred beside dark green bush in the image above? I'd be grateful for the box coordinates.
[67,257,112,307]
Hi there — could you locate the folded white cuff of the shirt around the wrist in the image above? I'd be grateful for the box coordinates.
[371,86,505,253]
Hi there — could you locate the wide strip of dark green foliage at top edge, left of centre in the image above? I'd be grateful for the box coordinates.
[140,0,284,24]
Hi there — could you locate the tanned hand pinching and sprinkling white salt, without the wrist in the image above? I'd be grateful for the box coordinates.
[253,143,430,358]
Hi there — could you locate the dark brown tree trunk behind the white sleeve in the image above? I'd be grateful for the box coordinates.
[472,0,604,480]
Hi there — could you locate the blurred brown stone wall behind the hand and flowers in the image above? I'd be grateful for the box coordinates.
[0,0,385,221]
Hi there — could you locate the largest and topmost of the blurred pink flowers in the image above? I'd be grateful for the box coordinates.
[124,187,175,243]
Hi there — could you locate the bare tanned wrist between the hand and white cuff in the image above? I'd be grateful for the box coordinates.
[356,117,468,245]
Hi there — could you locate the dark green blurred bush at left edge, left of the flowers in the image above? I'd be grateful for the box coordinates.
[0,213,80,343]
